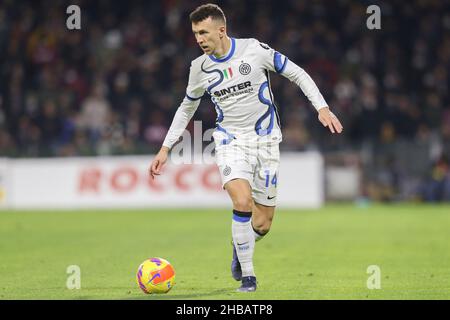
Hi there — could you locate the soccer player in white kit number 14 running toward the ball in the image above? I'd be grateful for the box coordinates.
[149,4,343,292]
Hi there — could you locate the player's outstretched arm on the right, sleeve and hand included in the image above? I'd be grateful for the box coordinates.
[258,43,343,133]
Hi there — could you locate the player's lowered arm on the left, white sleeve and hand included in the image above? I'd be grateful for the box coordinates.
[149,64,205,179]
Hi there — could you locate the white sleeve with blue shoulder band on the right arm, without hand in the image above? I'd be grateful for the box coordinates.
[257,41,328,111]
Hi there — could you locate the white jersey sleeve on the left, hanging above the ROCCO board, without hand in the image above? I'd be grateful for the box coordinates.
[163,65,205,149]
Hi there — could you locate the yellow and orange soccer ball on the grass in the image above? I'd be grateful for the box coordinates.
[136,258,175,293]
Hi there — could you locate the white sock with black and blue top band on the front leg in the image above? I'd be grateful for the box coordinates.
[231,210,255,277]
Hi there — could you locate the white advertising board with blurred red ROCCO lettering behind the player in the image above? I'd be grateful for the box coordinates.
[0,153,324,209]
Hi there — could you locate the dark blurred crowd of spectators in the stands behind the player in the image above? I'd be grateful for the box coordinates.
[0,0,450,201]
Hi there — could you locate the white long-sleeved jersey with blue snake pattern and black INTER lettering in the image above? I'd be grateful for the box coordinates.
[163,38,327,148]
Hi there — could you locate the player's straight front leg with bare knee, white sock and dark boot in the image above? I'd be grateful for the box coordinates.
[224,178,256,291]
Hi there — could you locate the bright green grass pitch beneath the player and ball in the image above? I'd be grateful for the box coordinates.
[0,205,450,299]
